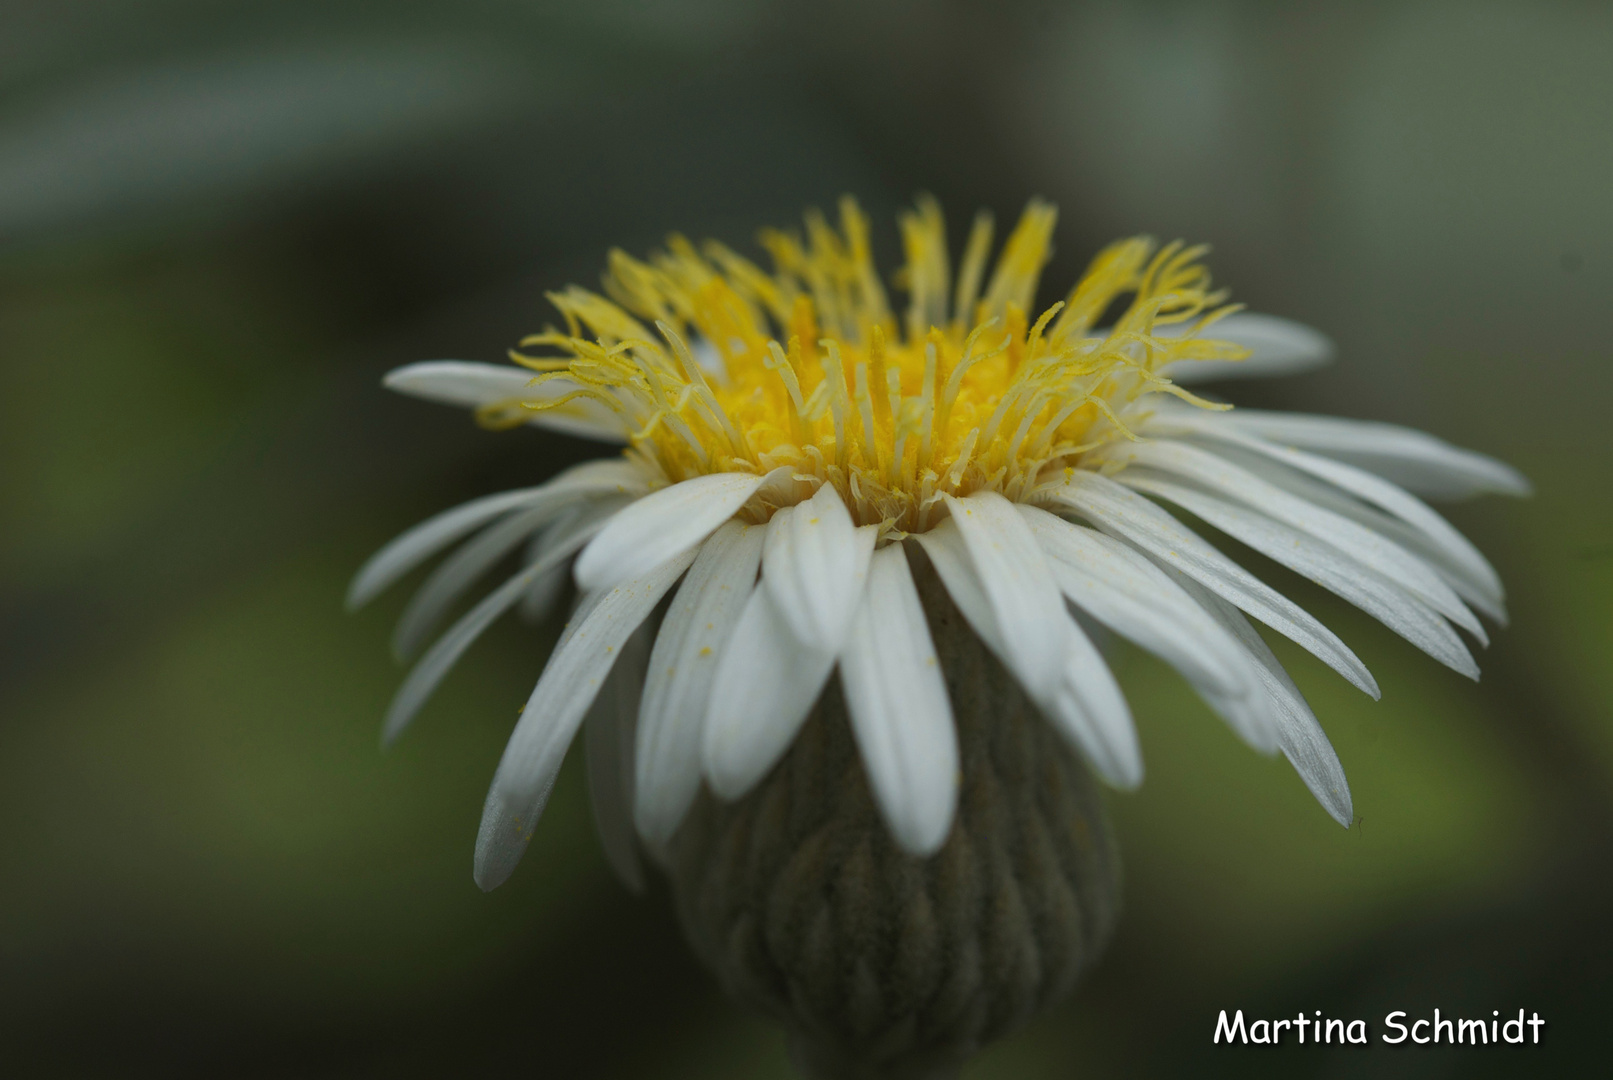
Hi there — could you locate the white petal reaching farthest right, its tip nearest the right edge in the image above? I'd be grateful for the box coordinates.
[1200,408,1531,498]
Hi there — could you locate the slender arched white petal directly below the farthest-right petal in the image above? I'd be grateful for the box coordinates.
[1144,409,1503,603]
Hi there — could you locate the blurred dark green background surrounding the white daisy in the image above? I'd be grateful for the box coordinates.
[0,0,1613,1078]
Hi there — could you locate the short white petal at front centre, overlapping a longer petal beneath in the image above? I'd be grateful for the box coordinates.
[761,484,879,653]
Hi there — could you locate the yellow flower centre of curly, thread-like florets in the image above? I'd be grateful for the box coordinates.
[481,198,1245,532]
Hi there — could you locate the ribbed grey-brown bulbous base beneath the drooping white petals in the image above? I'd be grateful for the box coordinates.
[669,557,1119,1080]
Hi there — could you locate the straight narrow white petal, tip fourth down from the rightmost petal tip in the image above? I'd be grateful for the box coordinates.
[1047,469,1379,698]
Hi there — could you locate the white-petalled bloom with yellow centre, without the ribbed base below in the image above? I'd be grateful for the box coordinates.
[348,198,1528,888]
